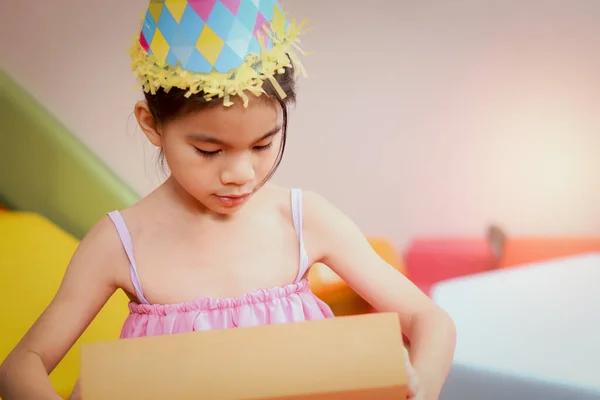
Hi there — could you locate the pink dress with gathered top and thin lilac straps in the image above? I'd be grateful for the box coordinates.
[108,189,334,339]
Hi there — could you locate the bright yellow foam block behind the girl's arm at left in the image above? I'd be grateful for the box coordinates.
[0,212,128,398]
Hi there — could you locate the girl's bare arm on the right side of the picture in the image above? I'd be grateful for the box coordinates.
[304,192,456,400]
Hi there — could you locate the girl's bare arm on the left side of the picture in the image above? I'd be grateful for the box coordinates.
[0,217,122,400]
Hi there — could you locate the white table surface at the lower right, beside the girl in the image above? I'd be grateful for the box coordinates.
[432,253,600,400]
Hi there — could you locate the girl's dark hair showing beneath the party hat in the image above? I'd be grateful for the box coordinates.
[144,67,296,183]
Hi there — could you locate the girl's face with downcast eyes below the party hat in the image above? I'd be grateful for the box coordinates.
[138,99,283,214]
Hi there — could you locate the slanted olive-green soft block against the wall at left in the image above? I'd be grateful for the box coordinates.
[0,70,139,239]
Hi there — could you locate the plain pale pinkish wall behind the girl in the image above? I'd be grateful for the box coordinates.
[0,0,600,245]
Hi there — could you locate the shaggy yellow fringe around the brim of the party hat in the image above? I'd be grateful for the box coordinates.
[129,20,306,107]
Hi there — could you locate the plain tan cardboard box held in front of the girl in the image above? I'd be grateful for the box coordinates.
[81,313,407,400]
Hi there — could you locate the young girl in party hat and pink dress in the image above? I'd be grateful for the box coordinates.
[0,0,455,400]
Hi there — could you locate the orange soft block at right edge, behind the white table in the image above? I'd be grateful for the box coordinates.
[500,236,600,268]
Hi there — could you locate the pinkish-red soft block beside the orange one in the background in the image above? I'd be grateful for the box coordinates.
[405,238,496,292]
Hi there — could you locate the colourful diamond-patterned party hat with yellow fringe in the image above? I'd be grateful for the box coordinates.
[130,0,304,105]
